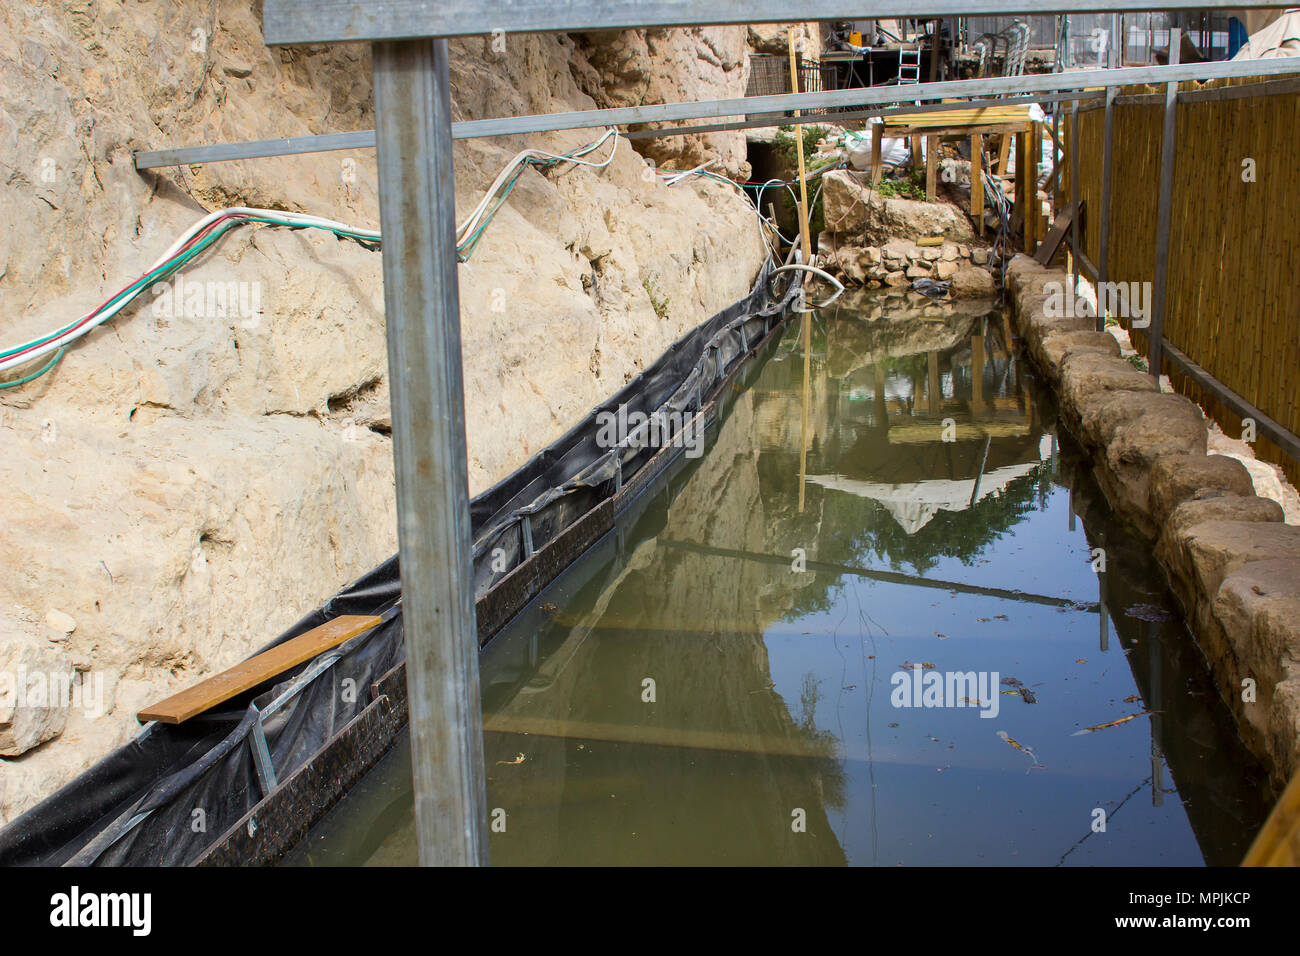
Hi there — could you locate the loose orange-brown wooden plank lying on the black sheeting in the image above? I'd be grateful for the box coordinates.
[135,614,380,723]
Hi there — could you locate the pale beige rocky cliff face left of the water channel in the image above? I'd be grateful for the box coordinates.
[0,0,763,821]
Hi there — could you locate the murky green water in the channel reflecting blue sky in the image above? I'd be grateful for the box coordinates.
[287,298,1266,866]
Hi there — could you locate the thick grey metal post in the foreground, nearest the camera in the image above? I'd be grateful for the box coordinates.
[372,39,488,866]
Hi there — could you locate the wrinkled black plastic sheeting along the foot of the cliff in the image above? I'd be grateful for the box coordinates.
[0,260,797,866]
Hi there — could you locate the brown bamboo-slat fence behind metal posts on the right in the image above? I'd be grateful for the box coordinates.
[1062,74,1300,483]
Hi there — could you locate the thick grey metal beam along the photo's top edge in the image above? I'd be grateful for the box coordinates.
[263,0,1275,47]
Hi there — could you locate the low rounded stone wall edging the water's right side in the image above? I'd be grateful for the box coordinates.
[1006,255,1300,790]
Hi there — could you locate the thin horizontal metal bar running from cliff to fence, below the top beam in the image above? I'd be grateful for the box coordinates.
[135,57,1300,169]
